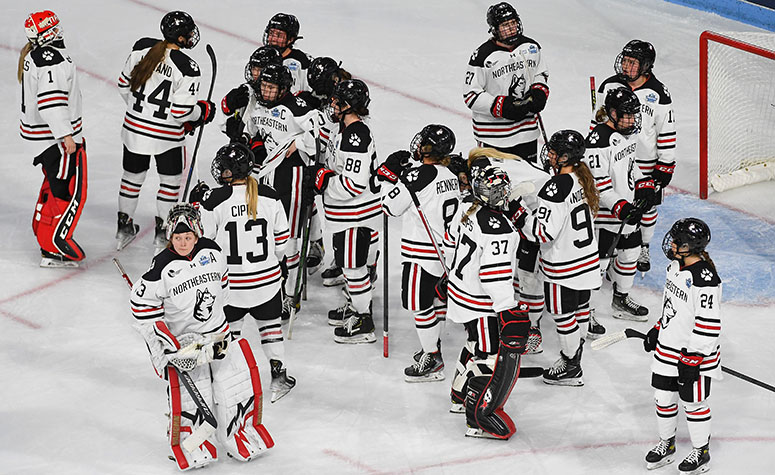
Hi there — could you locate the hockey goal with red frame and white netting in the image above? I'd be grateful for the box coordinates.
[700,31,775,199]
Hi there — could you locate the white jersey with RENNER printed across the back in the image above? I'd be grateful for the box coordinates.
[382,164,460,276]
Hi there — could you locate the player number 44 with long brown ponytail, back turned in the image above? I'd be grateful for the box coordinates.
[116,11,215,250]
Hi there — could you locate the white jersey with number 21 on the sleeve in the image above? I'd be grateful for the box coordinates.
[584,124,643,235]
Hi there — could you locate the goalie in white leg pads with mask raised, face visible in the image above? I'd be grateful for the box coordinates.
[130,204,274,470]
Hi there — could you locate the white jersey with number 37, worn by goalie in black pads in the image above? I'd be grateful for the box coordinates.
[447,206,518,323]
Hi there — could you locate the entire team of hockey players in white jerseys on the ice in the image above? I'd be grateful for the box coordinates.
[18,2,721,474]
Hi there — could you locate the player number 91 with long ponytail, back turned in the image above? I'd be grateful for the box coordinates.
[508,130,601,386]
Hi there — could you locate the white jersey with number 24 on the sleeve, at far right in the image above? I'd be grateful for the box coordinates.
[651,260,721,379]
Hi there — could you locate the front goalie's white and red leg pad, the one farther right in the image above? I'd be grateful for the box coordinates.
[211,338,274,462]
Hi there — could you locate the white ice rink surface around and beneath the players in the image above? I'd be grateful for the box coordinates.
[0,0,775,474]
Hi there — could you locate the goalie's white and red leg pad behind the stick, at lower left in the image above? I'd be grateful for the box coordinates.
[167,366,218,470]
